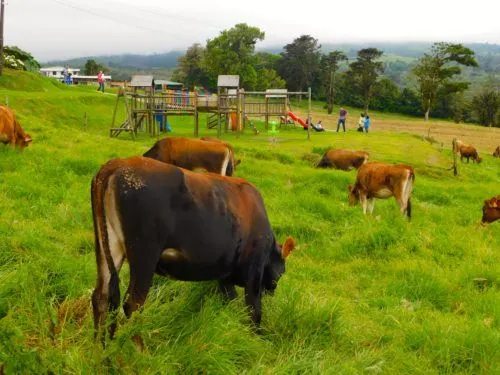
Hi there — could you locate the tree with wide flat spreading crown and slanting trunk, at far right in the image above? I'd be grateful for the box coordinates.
[412,42,477,121]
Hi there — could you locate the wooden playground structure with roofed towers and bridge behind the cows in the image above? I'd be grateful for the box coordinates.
[110,75,311,139]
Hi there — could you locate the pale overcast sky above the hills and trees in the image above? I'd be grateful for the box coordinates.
[4,0,500,61]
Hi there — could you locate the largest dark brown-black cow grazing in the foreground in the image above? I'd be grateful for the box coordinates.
[91,156,295,338]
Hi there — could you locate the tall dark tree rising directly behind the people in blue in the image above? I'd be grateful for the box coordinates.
[349,48,384,113]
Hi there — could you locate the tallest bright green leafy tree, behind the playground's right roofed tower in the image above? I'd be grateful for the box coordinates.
[202,23,265,89]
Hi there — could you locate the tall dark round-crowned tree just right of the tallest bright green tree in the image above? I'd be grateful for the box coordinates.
[278,35,321,91]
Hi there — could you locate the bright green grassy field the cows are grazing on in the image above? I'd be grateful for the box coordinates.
[0,71,500,374]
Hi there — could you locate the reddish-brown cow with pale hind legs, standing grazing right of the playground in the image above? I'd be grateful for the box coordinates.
[348,162,415,219]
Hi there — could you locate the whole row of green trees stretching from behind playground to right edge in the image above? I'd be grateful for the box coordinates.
[172,23,500,126]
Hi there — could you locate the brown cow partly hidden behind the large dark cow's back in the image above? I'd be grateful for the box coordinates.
[143,137,240,176]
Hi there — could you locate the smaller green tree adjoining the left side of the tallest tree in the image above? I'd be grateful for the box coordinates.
[172,43,211,88]
